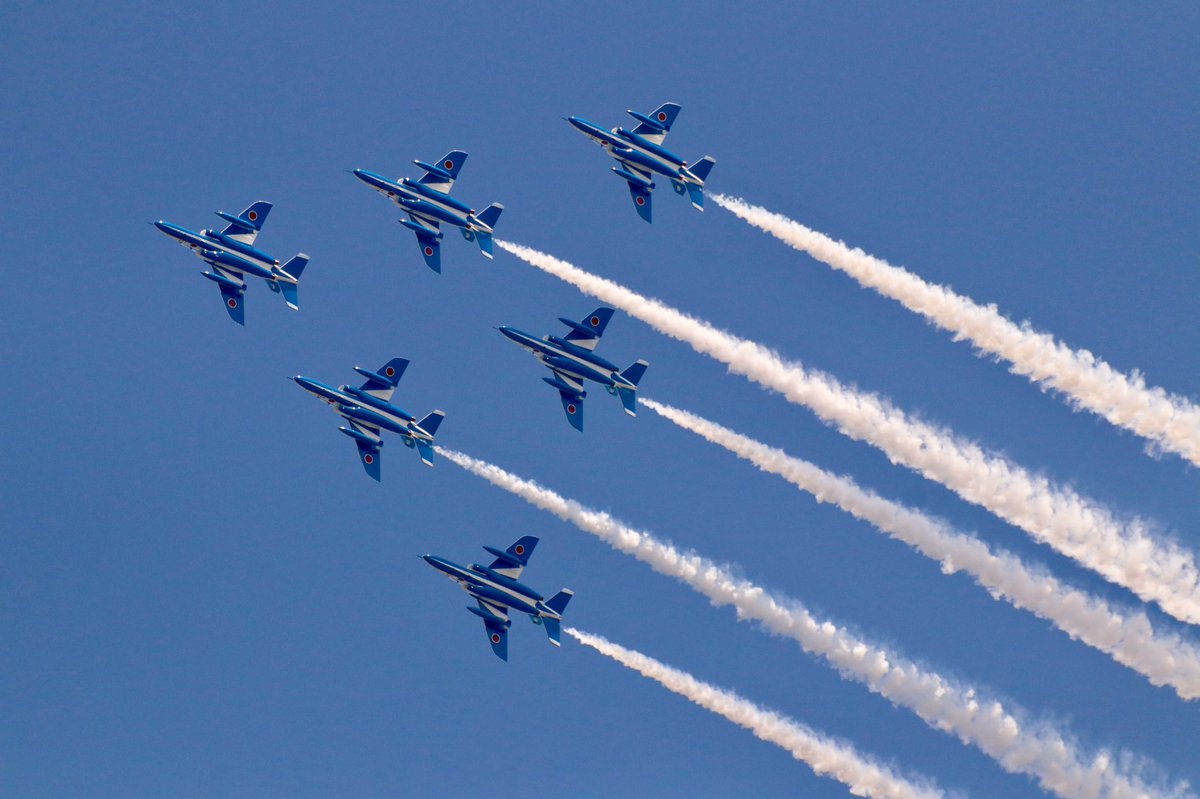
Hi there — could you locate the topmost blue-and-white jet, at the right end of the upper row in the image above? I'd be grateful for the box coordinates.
[566,103,716,222]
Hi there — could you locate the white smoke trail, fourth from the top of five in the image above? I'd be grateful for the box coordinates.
[440,450,1190,799]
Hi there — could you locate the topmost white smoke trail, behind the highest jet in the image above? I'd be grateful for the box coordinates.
[713,194,1200,465]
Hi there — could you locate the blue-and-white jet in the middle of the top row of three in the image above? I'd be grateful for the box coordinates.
[354,150,504,272]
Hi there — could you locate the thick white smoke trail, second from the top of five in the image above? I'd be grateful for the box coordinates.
[496,240,1200,624]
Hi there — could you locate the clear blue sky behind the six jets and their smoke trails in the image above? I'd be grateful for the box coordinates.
[0,2,1200,799]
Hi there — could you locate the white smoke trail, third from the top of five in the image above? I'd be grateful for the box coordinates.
[642,397,1200,699]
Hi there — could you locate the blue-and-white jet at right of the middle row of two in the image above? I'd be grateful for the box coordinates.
[497,306,649,432]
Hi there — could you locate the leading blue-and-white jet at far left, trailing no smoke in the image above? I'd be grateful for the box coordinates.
[154,200,308,325]
